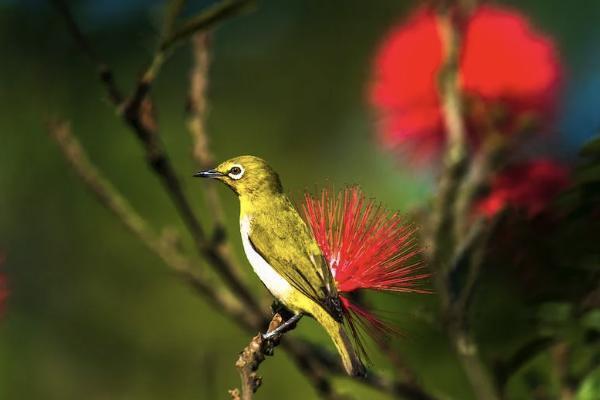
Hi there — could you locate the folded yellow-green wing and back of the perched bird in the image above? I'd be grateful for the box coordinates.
[248,199,342,321]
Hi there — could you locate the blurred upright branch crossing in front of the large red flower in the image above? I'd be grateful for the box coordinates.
[430,8,499,400]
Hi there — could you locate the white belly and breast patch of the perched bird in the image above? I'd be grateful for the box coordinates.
[240,217,294,302]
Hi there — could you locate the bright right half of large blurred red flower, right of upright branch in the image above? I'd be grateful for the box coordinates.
[460,6,560,114]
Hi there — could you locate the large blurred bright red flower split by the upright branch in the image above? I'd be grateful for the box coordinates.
[371,6,560,161]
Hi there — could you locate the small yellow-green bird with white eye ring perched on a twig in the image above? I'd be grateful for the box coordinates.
[194,156,366,376]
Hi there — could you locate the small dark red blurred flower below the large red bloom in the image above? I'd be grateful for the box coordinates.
[475,160,569,218]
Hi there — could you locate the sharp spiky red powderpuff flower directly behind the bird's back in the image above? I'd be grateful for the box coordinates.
[302,187,429,347]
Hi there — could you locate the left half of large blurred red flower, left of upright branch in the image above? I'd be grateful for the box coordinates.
[371,9,444,160]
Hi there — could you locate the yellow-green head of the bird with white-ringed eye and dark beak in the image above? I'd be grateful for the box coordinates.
[194,156,283,196]
